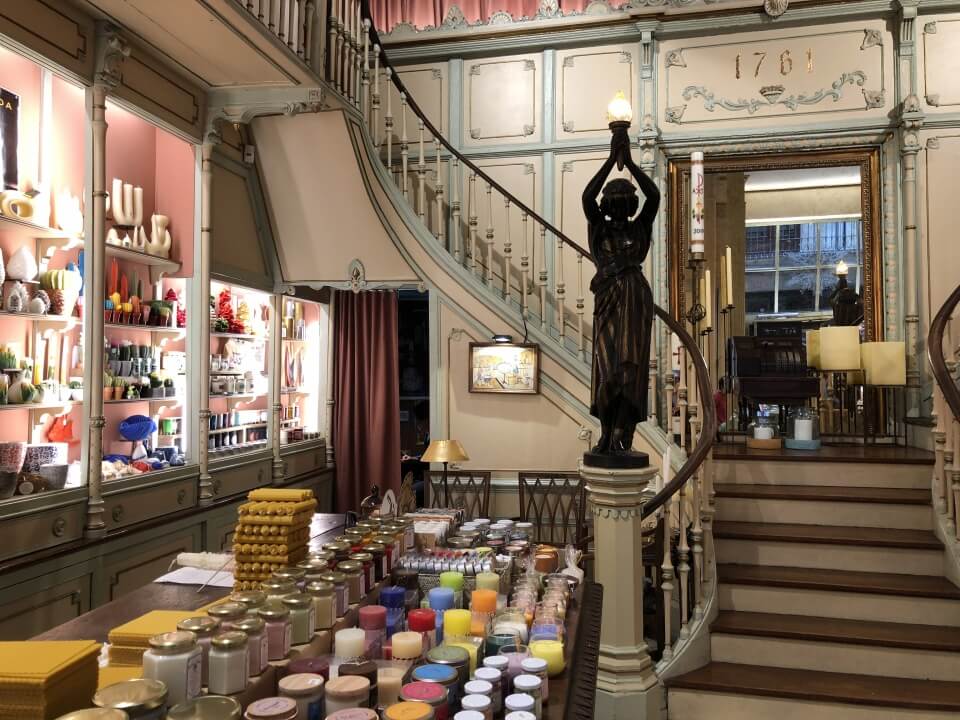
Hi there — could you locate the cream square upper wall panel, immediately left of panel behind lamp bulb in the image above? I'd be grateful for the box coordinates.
[463,55,543,146]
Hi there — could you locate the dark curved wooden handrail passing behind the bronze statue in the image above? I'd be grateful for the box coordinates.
[360,0,717,518]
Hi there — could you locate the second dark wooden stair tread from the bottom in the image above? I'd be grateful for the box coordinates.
[710,610,960,653]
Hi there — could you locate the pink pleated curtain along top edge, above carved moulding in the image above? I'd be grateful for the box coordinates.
[370,0,627,32]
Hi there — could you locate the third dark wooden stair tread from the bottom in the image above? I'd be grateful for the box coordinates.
[717,565,960,600]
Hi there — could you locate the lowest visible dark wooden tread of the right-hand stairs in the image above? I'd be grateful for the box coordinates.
[666,663,960,711]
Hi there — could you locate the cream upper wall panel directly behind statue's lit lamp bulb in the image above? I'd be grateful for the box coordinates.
[555,45,639,140]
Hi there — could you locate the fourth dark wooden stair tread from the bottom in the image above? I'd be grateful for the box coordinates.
[713,521,943,551]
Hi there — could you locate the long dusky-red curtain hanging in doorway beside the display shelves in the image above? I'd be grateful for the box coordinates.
[333,291,400,512]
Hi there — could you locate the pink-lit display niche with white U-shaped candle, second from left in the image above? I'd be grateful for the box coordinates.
[101,102,197,481]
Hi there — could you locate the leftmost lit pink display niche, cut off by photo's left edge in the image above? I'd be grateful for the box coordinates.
[0,48,86,500]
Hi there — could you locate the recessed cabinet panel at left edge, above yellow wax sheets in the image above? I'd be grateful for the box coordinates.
[0,574,91,640]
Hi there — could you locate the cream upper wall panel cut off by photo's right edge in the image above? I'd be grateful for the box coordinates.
[920,15,960,112]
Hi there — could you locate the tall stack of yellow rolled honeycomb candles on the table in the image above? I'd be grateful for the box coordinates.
[233,488,317,590]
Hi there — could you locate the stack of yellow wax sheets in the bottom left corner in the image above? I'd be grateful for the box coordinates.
[0,640,100,720]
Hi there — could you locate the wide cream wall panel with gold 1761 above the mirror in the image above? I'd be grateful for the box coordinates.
[660,21,894,131]
